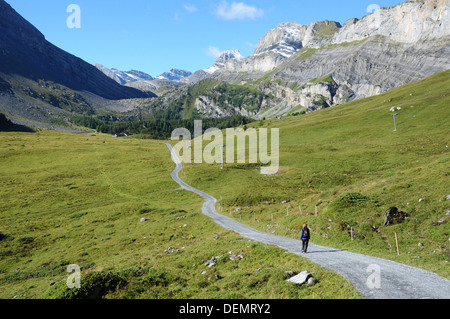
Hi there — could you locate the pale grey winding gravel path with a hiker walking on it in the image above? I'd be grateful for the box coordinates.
[166,144,450,299]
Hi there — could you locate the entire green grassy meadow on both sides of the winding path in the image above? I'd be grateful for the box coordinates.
[0,71,450,299]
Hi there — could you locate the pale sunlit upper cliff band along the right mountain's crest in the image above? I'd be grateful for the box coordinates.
[227,0,450,72]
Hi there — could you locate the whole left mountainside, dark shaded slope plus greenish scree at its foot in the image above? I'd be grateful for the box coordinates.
[0,0,156,126]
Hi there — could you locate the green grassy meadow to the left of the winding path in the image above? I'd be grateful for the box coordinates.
[0,130,358,298]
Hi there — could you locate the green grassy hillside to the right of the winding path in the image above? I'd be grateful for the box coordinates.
[181,71,450,278]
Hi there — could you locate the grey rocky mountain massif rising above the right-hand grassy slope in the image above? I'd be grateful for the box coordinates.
[199,0,450,117]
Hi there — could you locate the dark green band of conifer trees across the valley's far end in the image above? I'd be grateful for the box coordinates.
[71,115,253,139]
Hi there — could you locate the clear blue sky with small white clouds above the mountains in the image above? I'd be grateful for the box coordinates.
[6,0,403,76]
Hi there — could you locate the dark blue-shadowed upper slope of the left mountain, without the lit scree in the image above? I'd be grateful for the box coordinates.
[0,0,151,100]
